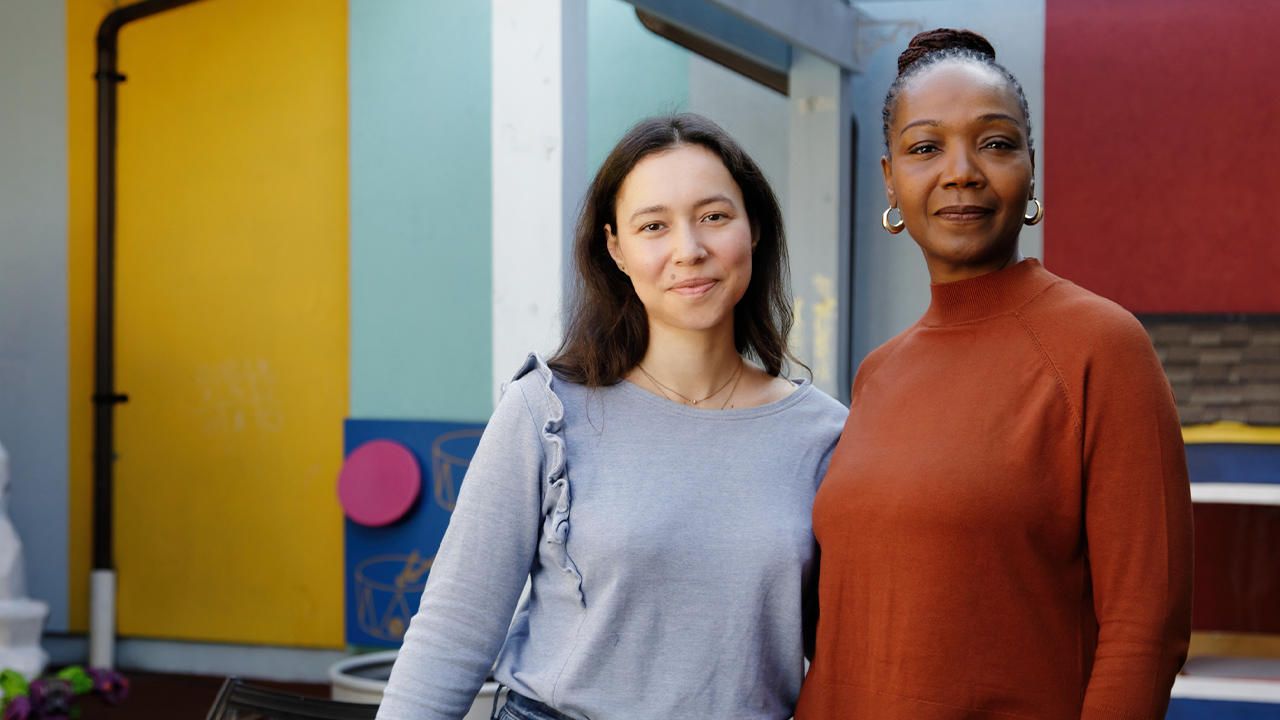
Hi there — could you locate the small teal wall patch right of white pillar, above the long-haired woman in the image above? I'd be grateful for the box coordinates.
[586,0,689,174]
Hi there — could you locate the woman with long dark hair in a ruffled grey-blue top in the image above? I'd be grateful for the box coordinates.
[379,114,846,720]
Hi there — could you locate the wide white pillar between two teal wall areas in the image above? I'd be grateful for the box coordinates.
[492,0,586,402]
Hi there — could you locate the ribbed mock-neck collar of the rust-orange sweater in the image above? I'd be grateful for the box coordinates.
[920,258,1059,327]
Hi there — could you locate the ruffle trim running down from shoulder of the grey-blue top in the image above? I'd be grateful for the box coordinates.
[511,352,586,607]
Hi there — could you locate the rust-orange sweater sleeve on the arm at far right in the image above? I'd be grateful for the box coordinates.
[1082,310,1192,720]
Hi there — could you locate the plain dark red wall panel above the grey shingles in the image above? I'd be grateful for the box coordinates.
[1044,0,1280,313]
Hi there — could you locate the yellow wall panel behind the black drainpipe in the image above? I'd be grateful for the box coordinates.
[68,0,348,647]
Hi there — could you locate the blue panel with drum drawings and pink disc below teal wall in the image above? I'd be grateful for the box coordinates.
[338,420,484,647]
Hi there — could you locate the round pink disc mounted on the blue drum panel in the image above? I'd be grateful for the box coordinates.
[338,439,422,528]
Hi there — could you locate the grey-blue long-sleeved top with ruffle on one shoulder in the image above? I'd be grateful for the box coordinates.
[378,355,847,720]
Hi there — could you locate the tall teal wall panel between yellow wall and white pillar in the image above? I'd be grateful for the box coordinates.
[348,0,493,420]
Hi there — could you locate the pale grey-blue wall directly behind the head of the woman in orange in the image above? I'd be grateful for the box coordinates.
[852,0,1052,363]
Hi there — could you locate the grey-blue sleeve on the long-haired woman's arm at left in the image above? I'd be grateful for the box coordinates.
[378,382,543,720]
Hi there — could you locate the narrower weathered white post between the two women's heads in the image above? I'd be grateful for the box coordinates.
[787,49,852,402]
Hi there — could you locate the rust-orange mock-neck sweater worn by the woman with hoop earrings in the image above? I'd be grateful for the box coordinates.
[796,260,1192,720]
